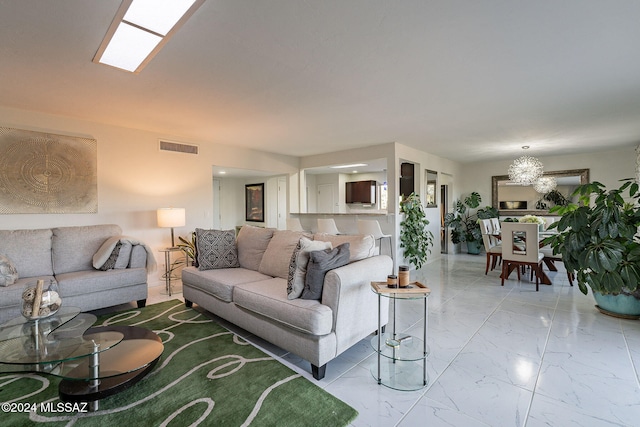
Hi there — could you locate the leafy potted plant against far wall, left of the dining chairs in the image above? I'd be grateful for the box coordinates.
[444,191,498,255]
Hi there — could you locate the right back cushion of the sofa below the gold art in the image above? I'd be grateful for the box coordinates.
[52,224,122,275]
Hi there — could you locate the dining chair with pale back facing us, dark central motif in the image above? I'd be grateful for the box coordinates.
[501,222,544,292]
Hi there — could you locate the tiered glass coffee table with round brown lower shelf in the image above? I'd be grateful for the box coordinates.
[0,307,164,410]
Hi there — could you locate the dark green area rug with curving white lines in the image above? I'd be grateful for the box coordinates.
[0,300,358,426]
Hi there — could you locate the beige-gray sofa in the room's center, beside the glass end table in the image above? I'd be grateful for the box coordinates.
[182,226,393,380]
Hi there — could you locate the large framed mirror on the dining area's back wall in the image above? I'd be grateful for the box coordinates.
[491,169,589,216]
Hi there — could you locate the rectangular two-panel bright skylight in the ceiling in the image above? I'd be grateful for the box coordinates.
[93,0,205,73]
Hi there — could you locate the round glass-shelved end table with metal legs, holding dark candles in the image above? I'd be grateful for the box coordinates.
[371,282,431,391]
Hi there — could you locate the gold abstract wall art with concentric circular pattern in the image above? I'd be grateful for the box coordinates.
[0,127,98,214]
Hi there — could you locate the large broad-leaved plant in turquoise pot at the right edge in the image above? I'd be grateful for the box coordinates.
[543,179,640,317]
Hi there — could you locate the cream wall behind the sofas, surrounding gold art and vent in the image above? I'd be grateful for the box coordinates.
[0,107,299,254]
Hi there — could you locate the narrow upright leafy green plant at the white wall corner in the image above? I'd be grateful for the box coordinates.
[400,193,433,268]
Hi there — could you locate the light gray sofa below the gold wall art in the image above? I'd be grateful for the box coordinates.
[0,225,155,322]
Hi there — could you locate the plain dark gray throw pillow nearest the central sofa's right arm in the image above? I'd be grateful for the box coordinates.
[300,243,349,300]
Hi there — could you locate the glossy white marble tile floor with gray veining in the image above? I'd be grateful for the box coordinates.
[106,254,640,427]
